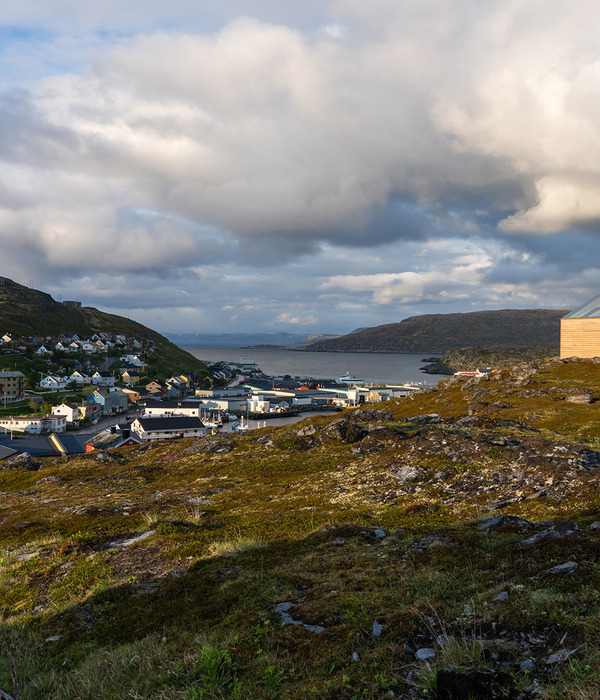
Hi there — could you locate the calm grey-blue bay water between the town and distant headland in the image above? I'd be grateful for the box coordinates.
[181,345,446,385]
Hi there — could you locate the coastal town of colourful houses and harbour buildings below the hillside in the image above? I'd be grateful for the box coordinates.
[0,333,419,459]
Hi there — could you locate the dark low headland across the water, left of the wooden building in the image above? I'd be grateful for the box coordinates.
[302,309,568,354]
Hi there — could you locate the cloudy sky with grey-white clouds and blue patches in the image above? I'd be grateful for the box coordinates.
[0,0,600,334]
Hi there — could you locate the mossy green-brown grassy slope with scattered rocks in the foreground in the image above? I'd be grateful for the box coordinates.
[0,362,600,700]
